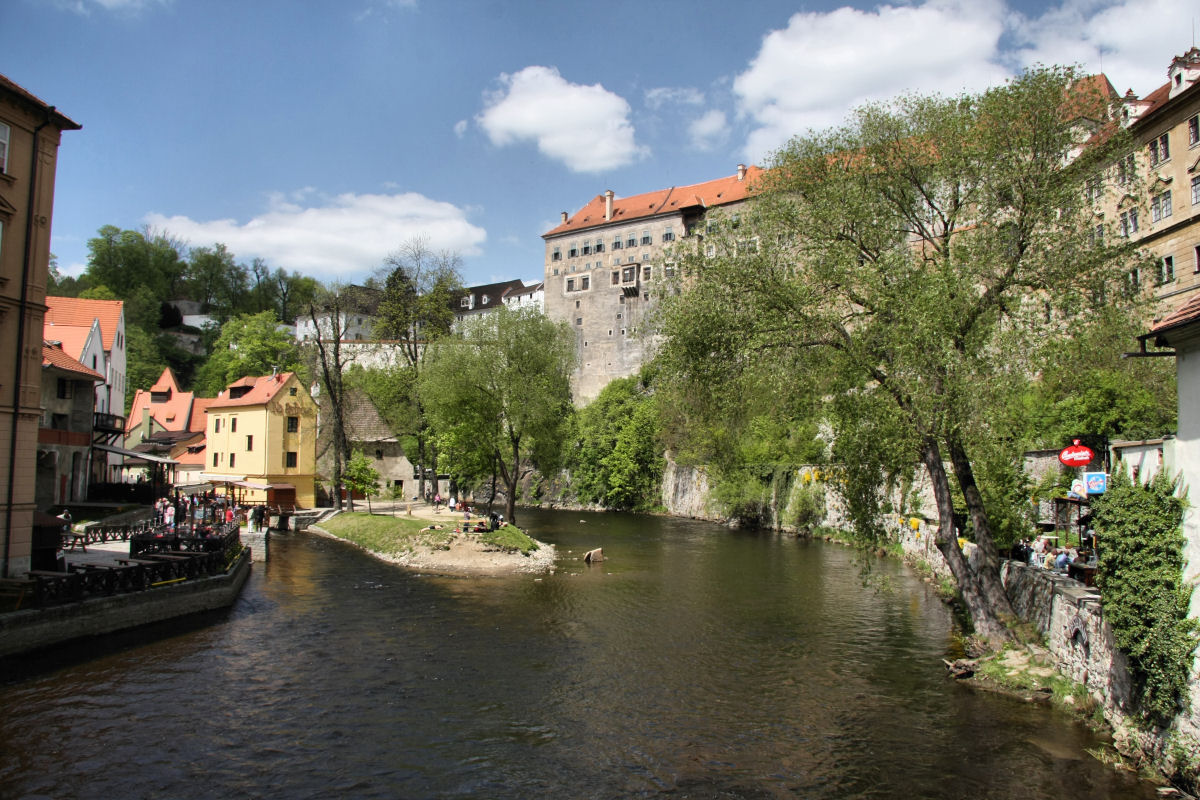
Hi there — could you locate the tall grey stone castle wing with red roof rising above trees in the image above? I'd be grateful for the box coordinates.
[542,164,762,404]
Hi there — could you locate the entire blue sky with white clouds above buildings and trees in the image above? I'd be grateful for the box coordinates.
[0,0,1200,284]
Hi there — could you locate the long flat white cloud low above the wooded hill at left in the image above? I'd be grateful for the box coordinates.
[143,188,487,281]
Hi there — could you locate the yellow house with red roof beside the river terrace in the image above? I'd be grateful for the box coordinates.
[200,372,317,507]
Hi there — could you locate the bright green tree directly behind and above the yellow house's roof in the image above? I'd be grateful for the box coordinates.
[194,311,301,397]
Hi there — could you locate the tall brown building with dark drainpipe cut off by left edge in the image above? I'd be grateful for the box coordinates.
[0,76,80,578]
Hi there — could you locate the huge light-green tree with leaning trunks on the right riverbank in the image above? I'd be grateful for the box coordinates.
[664,68,1130,640]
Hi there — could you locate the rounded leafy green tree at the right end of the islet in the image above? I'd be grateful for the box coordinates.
[418,307,575,522]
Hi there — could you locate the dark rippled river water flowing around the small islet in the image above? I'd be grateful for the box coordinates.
[0,511,1154,800]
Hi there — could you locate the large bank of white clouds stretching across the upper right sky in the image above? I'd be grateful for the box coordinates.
[733,0,1194,162]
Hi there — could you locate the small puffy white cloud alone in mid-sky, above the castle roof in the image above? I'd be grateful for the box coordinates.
[475,66,647,173]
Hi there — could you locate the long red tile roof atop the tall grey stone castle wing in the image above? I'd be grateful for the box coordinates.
[542,167,763,239]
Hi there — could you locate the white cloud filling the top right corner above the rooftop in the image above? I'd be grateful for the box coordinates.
[1012,0,1195,95]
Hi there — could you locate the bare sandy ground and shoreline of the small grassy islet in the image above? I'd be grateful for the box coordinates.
[308,503,556,577]
